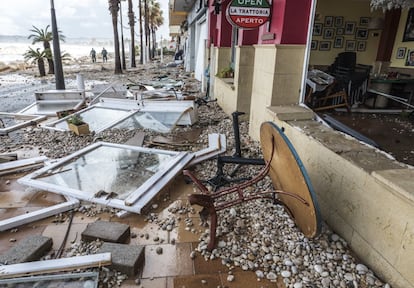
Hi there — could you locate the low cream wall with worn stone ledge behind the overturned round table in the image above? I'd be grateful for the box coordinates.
[267,109,414,288]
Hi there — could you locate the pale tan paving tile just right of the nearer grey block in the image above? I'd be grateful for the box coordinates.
[142,243,193,278]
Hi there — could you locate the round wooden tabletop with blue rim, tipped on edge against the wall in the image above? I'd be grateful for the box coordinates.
[260,122,321,238]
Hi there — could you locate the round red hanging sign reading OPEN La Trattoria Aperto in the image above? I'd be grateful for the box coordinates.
[226,0,270,29]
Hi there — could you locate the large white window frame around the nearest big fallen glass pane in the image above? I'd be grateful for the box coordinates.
[18,142,194,214]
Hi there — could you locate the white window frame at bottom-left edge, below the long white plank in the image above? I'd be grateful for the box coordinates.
[0,272,99,288]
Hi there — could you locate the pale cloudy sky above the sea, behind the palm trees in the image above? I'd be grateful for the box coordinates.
[0,0,169,39]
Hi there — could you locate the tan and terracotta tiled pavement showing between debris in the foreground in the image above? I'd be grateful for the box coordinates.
[0,172,284,288]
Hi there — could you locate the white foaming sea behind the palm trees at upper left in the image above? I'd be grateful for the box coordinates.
[0,35,115,65]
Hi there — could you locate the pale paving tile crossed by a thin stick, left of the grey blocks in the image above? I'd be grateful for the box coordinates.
[42,223,87,250]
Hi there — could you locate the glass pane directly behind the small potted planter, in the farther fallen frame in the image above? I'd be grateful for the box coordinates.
[55,107,130,131]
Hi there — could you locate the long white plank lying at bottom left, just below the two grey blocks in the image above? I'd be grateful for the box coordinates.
[0,253,112,278]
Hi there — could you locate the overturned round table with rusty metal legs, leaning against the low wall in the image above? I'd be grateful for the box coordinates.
[184,122,321,251]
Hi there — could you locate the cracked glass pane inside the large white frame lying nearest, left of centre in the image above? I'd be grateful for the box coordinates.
[36,146,175,200]
